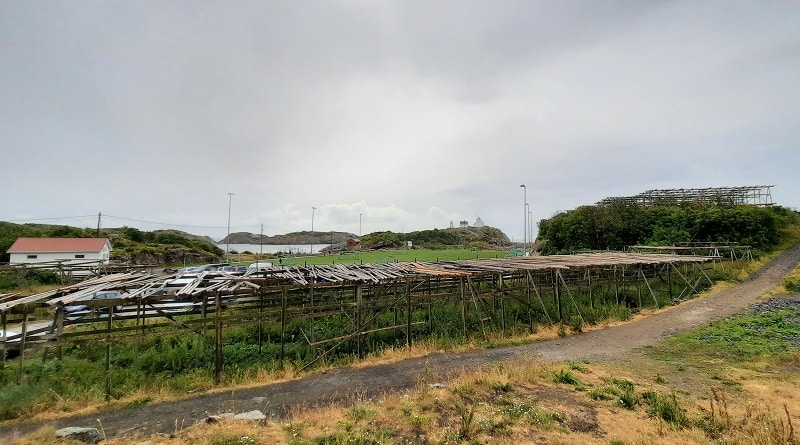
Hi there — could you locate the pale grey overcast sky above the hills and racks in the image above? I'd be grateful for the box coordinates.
[0,0,800,241]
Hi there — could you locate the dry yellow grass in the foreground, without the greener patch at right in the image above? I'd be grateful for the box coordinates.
[11,355,800,445]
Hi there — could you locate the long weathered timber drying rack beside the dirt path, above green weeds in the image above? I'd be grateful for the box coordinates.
[0,252,713,393]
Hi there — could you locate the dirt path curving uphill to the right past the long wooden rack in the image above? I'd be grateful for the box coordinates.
[0,245,800,439]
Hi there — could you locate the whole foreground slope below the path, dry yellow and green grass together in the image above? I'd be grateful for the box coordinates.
[10,268,800,445]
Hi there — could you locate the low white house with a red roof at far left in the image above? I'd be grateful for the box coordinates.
[6,238,111,264]
